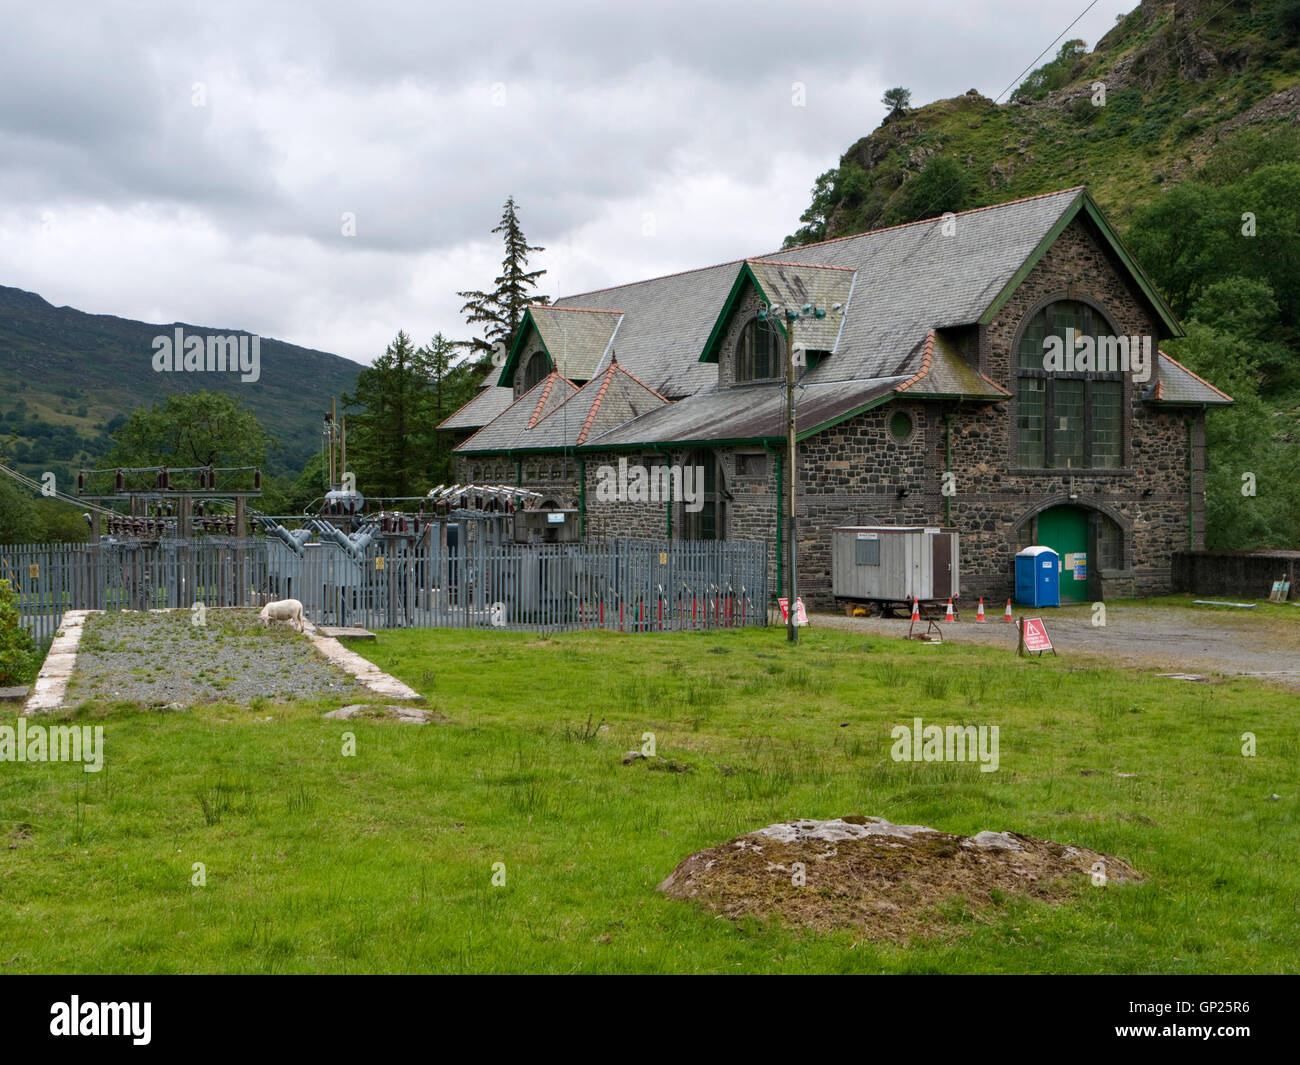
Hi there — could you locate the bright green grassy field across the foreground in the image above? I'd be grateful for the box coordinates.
[0,629,1300,973]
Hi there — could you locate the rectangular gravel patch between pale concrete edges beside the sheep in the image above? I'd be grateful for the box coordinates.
[68,610,367,706]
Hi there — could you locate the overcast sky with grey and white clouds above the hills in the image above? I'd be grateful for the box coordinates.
[0,0,1136,362]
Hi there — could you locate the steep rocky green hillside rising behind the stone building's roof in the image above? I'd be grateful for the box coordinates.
[787,0,1300,244]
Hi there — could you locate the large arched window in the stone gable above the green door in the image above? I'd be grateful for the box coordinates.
[1015,299,1125,469]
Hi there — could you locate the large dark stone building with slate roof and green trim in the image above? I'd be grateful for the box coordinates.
[442,189,1231,606]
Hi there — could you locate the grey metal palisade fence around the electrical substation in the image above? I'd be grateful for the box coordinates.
[0,537,768,640]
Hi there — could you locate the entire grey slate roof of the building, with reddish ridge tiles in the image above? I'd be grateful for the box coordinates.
[441,187,1231,450]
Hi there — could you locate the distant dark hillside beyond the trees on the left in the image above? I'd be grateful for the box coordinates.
[0,286,361,476]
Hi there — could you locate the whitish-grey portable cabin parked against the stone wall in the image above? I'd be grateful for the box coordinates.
[831,525,961,602]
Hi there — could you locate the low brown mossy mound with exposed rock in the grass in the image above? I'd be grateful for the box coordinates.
[659,815,1141,941]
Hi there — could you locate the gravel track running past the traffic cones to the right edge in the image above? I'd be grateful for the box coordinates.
[809,603,1300,689]
